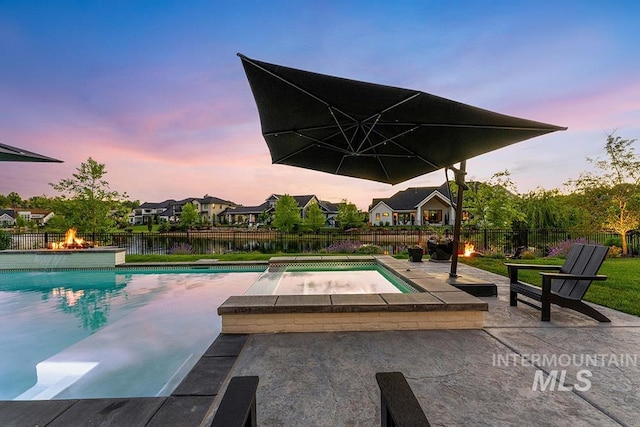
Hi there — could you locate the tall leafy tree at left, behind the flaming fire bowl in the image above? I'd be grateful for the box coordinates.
[49,157,126,233]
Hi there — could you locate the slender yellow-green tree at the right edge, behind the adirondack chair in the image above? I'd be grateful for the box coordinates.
[568,134,640,254]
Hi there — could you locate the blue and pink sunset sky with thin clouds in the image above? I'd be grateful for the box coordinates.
[0,0,640,209]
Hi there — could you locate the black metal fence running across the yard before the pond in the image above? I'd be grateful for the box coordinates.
[6,227,640,255]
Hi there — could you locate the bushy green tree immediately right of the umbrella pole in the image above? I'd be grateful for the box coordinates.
[463,170,524,228]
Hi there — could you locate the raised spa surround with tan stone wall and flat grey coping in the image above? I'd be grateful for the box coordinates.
[218,256,489,334]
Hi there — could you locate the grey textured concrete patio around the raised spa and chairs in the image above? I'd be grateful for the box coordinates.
[207,262,640,426]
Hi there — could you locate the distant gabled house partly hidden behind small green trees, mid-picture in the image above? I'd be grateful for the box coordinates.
[223,194,338,226]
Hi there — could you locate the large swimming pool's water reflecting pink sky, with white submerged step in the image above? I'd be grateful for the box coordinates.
[0,270,262,400]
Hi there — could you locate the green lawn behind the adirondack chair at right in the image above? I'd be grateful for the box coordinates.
[460,257,640,316]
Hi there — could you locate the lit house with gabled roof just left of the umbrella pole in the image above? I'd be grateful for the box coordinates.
[369,182,455,225]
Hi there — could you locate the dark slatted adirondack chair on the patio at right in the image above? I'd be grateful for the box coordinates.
[505,244,611,322]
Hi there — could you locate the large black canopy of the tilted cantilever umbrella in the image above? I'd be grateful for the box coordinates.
[238,54,566,184]
